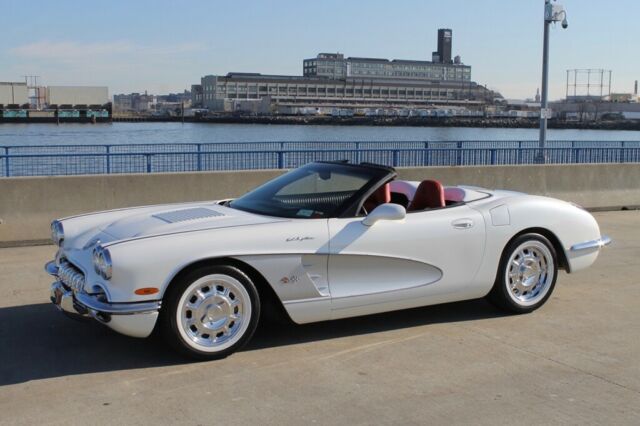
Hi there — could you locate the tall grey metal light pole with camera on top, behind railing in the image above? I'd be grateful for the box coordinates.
[537,0,569,163]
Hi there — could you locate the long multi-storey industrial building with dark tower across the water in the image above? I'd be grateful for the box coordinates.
[191,29,499,113]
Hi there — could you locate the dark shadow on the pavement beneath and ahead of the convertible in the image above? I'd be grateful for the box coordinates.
[0,300,503,386]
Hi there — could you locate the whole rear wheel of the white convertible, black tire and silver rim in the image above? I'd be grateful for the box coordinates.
[487,233,558,314]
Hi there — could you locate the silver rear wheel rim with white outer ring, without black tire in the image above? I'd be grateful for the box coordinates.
[505,240,555,306]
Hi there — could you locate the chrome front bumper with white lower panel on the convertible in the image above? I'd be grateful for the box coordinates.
[44,262,162,337]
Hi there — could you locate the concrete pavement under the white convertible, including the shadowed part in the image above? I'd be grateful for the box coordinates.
[0,211,640,425]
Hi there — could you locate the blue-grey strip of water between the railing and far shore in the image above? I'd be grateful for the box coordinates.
[0,123,640,146]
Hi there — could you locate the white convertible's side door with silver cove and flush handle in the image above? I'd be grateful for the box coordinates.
[328,205,485,318]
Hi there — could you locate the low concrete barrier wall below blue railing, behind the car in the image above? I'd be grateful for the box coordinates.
[0,164,640,246]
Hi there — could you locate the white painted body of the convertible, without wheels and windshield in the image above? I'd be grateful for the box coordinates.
[47,181,600,337]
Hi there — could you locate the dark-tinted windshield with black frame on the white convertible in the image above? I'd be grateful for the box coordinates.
[229,163,388,219]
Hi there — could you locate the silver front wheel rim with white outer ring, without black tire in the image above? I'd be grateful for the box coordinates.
[176,274,251,352]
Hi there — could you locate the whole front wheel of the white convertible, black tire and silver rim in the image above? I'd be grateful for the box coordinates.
[158,265,260,360]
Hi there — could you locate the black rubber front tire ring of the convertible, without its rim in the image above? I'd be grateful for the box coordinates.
[160,265,260,360]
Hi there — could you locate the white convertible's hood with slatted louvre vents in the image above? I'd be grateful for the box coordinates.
[70,202,286,249]
